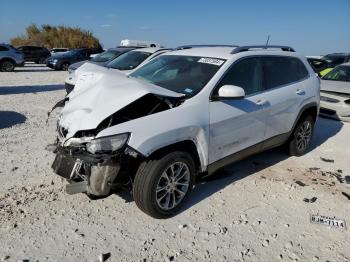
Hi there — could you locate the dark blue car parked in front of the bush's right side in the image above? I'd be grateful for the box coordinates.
[46,48,103,71]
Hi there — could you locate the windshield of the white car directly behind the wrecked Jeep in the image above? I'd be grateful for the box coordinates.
[107,51,151,70]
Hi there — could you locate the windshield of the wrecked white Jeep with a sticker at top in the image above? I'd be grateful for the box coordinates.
[130,55,225,97]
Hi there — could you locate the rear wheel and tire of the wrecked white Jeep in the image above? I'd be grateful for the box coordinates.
[288,115,315,156]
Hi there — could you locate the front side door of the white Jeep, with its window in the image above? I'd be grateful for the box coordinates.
[209,57,269,165]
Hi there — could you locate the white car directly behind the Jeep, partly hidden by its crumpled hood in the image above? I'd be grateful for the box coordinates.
[66,47,172,94]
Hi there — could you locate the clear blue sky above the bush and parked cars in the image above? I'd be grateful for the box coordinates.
[0,0,350,55]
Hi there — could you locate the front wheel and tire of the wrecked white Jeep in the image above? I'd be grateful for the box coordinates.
[133,151,196,219]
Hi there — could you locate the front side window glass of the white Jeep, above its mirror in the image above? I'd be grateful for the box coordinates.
[218,57,263,95]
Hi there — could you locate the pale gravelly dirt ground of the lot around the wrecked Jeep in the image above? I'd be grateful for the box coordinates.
[0,65,350,261]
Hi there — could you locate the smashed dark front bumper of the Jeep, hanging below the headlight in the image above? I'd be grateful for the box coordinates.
[52,146,120,196]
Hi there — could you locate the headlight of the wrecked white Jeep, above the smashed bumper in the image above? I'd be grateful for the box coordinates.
[86,134,129,154]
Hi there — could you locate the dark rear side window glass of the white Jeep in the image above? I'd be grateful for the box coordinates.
[262,56,308,90]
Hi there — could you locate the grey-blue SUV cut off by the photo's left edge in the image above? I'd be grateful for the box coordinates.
[0,44,24,72]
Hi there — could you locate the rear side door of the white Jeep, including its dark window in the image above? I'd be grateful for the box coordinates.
[261,56,309,139]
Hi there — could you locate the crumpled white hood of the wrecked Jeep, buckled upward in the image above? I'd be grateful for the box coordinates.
[59,63,183,139]
